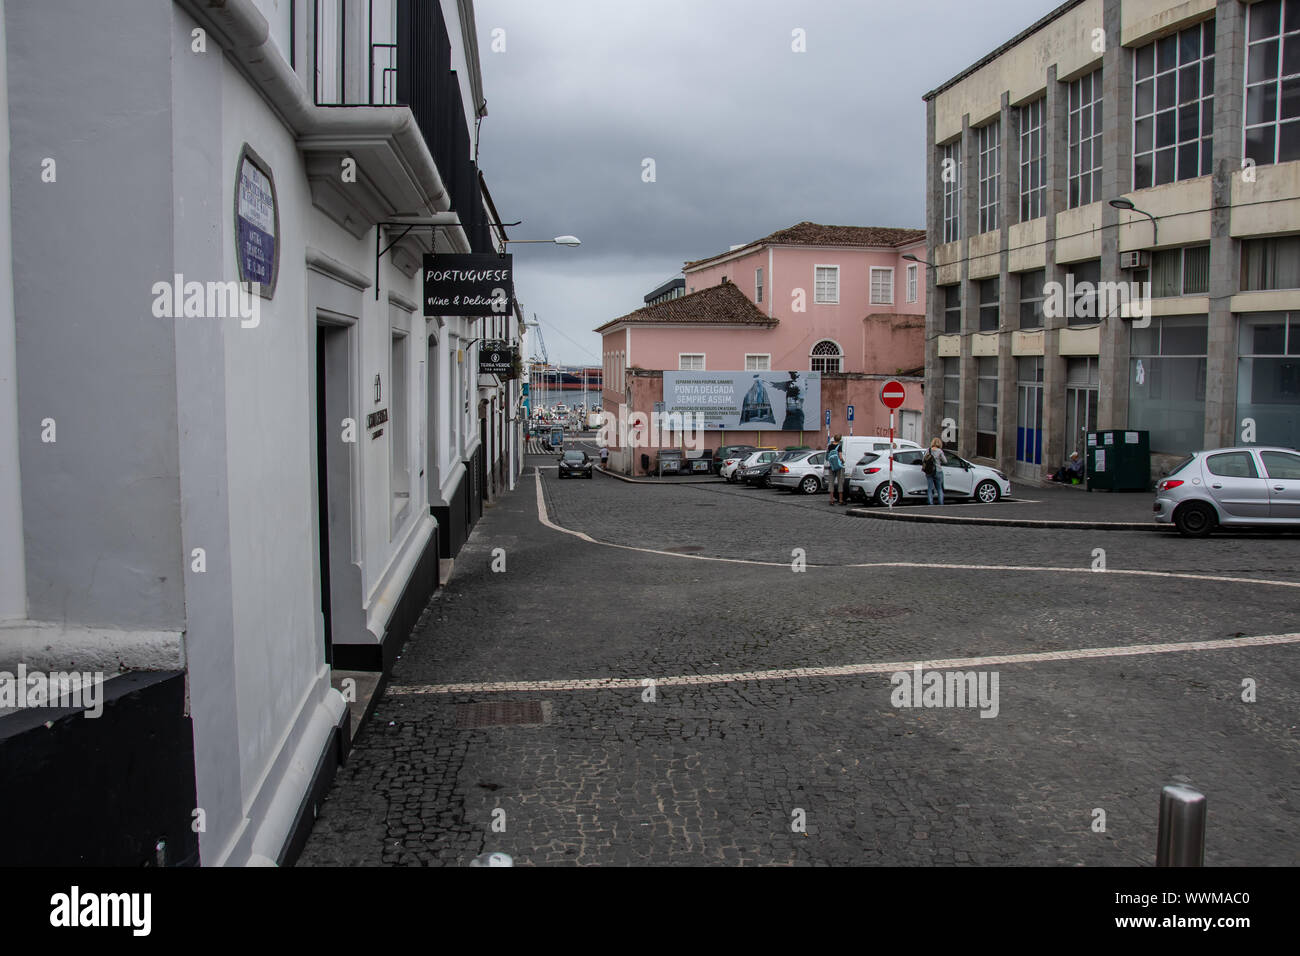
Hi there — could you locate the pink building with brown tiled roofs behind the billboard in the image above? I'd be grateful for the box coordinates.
[597,222,926,473]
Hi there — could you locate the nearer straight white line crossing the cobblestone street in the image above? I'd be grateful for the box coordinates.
[387,633,1300,696]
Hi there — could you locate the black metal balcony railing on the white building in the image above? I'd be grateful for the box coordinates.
[313,0,494,252]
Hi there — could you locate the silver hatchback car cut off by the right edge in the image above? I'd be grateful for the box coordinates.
[1152,445,1300,537]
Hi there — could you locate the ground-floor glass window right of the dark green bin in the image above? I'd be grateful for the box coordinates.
[1128,315,1209,455]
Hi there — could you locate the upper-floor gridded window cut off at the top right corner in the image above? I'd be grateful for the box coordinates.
[1244,0,1300,165]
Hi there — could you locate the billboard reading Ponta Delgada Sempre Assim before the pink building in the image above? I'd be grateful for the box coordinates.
[663,371,822,432]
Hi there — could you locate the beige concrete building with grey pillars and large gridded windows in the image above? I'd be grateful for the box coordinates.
[924,0,1300,477]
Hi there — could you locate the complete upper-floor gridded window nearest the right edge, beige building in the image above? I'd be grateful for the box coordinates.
[1134,20,1214,189]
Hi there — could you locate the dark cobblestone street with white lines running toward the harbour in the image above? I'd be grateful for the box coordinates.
[302,457,1300,866]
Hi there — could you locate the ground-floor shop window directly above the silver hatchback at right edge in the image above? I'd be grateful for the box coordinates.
[1235,312,1300,447]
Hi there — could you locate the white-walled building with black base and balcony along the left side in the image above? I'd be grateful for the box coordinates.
[0,0,520,865]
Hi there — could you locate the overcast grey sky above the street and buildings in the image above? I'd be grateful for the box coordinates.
[475,0,1060,364]
